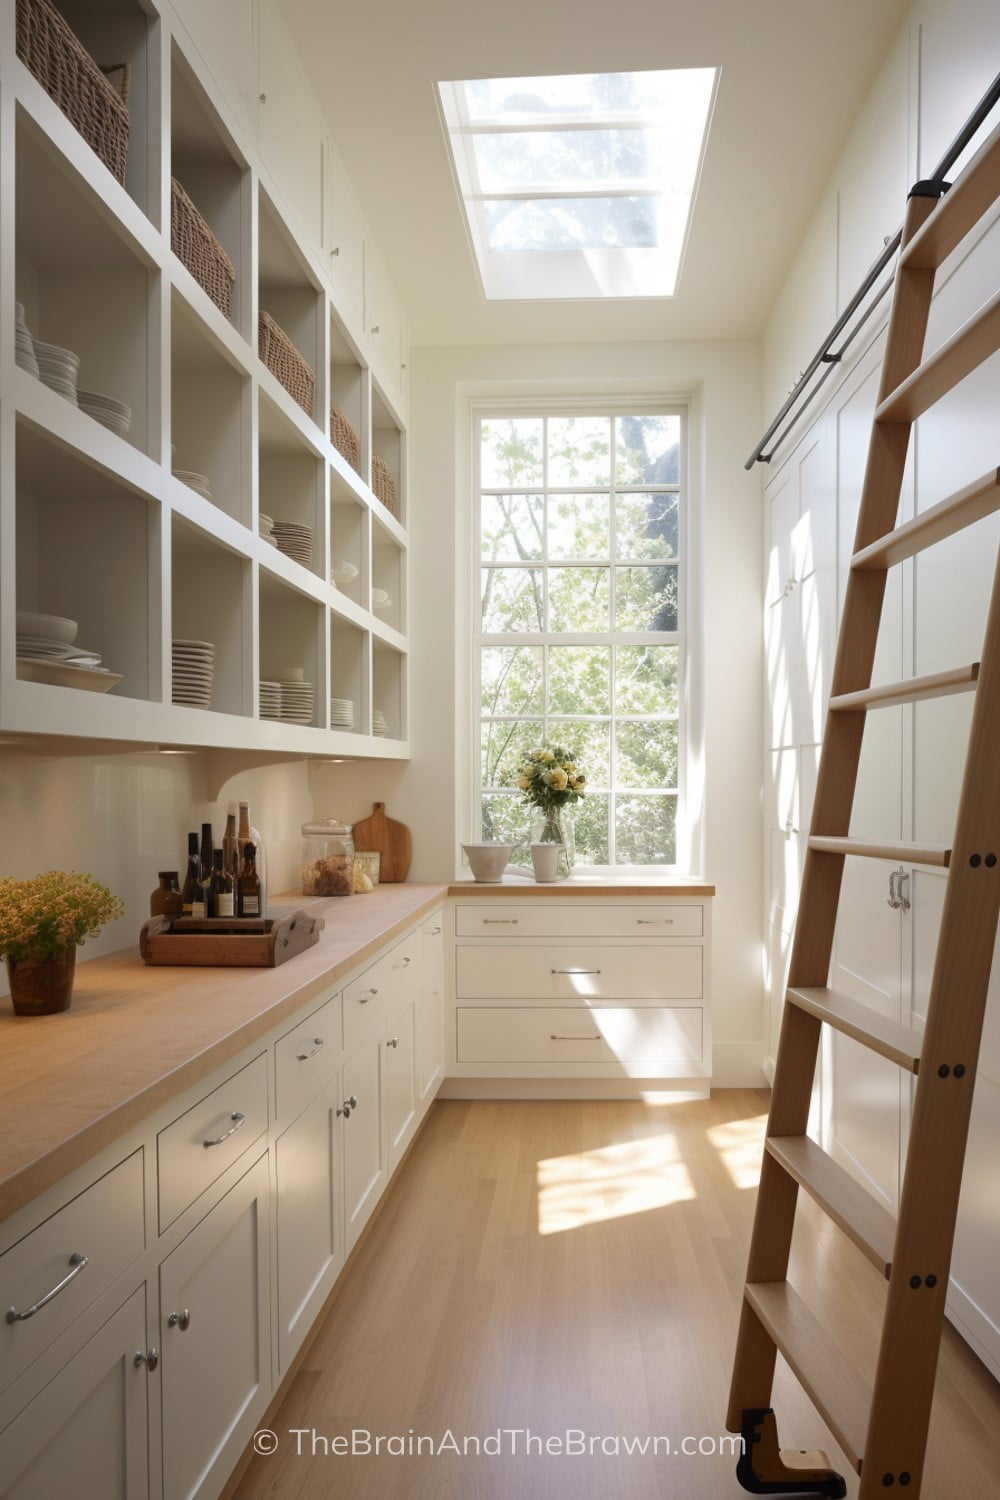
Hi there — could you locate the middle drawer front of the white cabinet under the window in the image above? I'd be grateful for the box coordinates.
[456,942,702,1001]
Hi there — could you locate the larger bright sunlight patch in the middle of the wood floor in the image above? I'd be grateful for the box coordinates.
[538,1136,697,1235]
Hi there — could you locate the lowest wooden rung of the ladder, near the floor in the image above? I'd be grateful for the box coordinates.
[744,1281,871,1473]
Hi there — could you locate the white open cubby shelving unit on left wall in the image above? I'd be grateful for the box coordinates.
[0,0,409,759]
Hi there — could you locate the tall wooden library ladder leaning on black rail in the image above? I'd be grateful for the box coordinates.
[727,111,1000,1500]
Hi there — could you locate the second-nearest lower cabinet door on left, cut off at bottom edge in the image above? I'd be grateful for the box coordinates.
[159,1157,270,1500]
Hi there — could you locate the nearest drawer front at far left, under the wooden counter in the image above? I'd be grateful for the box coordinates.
[0,1151,145,1386]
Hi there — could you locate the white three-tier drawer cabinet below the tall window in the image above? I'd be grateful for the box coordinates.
[448,888,712,1097]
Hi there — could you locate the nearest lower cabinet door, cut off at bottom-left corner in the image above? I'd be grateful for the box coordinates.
[0,1287,148,1500]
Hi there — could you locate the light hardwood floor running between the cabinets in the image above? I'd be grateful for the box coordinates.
[234,1089,1000,1500]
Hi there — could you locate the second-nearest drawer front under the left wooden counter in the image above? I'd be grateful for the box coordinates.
[156,1055,267,1235]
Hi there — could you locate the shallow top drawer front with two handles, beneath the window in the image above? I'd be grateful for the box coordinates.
[454,900,705,938]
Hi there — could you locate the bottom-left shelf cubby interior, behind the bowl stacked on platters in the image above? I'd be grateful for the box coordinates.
[15,422,160,699]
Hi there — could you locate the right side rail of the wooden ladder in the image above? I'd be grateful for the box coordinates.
[861,543,1000,1497]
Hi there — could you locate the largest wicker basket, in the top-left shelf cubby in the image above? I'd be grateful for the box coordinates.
[16,0,130,183]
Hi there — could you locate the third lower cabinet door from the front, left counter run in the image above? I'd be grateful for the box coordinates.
[274,1083,343,1374]
